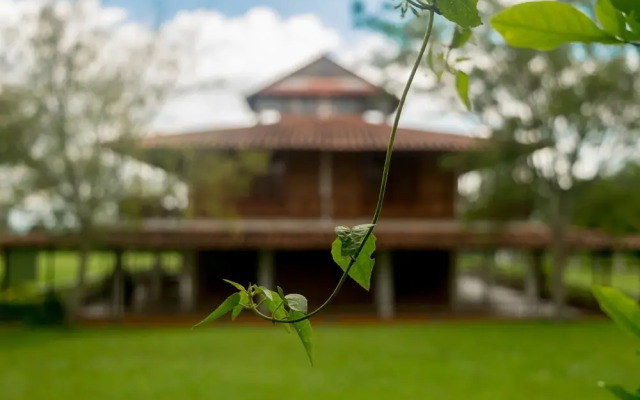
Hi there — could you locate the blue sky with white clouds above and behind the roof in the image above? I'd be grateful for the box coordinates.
[0,0,477,134]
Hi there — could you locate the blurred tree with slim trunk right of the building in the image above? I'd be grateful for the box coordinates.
[352,1,640,315]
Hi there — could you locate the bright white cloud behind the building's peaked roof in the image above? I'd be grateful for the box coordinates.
[153,8,475,132]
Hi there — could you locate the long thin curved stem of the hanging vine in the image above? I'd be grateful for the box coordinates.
[252,8,436,324]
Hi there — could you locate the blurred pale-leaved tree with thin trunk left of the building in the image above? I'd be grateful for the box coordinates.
[0,1,174,315]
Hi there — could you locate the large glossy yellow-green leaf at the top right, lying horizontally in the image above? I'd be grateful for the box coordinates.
[491,1,619,50]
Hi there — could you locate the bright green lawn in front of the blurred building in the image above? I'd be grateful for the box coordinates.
[0,322,640,400]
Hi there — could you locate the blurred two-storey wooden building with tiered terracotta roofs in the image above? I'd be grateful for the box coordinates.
[0,57,624,318]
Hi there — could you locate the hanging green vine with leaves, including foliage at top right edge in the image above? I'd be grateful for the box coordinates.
[196,0,640,362]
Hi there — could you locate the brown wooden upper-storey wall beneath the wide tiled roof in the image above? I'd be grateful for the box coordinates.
[192,152,457,219]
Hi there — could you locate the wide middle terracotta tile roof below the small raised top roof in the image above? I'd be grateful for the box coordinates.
[142,116,481,151]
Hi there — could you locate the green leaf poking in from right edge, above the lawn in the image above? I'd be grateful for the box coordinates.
[593,286,640,338]
